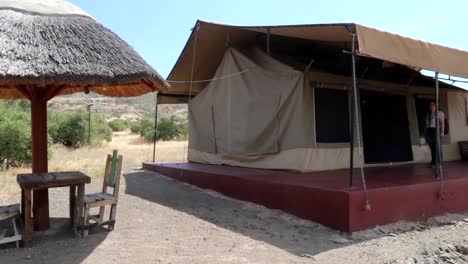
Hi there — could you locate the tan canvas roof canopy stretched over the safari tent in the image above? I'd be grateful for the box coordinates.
[163,20,468,101]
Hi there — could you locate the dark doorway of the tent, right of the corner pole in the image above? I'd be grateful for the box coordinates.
[360,90,413,164]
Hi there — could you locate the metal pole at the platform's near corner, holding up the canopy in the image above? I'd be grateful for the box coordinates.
[349,33,357,187]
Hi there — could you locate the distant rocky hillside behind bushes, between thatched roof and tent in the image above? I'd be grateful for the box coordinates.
[48,93,187,120]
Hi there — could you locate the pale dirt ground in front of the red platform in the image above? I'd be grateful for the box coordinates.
[0,170,468,264]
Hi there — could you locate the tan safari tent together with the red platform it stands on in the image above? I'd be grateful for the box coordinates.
[143,21,468,232]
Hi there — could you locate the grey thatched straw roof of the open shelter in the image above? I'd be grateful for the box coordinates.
[0,0,168,99]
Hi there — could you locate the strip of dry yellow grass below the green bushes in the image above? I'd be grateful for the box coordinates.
[0,131,187,199]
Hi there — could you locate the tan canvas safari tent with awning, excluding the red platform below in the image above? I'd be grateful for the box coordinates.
[158,21,468,171]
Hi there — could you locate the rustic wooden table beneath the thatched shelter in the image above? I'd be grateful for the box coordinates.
[16,171,91,247]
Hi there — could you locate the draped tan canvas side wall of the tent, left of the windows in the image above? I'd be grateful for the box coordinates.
[189,49,313,155]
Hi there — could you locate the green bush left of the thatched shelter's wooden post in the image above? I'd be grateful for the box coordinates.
[0,103,31,169]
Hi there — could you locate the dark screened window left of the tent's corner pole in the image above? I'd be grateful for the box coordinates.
[315,88,349,143]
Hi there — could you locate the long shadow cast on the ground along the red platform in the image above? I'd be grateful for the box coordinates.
[124,171,358,256]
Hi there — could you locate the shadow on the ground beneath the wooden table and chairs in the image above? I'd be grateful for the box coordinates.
[0,218,108,264]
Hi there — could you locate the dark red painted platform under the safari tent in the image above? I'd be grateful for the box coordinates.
[143,162,468,232]
